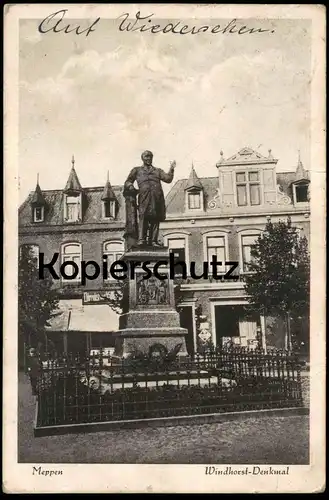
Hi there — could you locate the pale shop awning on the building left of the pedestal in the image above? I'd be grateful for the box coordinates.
[47,300,119,332]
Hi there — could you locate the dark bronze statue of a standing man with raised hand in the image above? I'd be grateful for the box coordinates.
[124,151,176,246]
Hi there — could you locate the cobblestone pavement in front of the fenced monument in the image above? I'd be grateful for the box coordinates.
[18,374,309,464]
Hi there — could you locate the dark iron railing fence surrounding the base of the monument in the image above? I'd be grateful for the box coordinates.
[36,348,303,427]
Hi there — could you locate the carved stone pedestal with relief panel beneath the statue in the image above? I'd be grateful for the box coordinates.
[115,247,187,357]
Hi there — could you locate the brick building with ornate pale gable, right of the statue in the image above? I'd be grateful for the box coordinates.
[162,148,310,354]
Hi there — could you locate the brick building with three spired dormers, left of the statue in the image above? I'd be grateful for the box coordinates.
[19,159,125,351]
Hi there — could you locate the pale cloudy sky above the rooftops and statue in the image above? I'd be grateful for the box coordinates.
[19,19,311,201]
